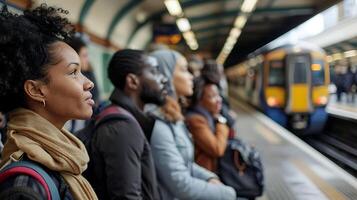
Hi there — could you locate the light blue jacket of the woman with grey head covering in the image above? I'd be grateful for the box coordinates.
[150,120,236,200]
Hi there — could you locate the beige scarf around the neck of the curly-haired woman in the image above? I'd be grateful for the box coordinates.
[0,108,98,200]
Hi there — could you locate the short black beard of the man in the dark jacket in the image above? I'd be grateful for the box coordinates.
[140,84,165,106]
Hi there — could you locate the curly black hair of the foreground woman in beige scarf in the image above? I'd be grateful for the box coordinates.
[0,4,73,112]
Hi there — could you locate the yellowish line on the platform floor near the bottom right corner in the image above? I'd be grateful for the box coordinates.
[293,160,348,200]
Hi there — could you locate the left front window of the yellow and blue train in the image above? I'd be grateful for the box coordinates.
[268,60,285,86]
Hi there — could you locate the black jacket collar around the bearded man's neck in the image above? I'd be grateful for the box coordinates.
[109,89,155,140]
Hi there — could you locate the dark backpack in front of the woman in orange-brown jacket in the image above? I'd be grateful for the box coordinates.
[217,139,264,198]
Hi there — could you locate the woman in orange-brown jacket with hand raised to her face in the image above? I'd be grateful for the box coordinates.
[186,78,229,172]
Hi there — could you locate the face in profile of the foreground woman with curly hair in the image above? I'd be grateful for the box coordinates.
[40,42,94,121]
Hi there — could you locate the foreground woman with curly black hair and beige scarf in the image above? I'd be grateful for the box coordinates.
[0,4,97,200]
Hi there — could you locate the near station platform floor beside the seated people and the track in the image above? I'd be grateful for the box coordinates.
[231,99,357,200]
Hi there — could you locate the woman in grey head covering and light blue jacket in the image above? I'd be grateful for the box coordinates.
[150,50,236,200]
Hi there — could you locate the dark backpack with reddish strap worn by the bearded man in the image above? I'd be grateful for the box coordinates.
[74,104,138,181]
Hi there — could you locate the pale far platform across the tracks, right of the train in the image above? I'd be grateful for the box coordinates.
[326,94,357,120]
